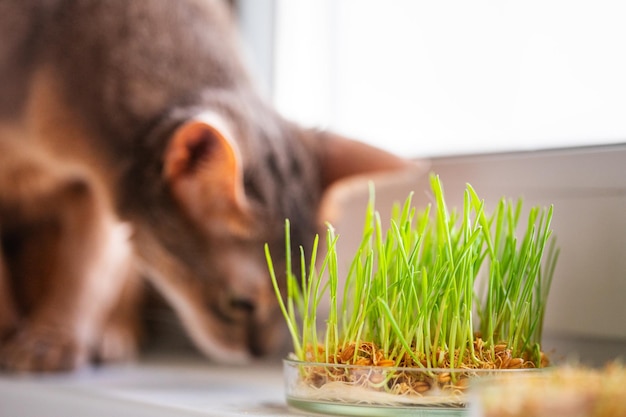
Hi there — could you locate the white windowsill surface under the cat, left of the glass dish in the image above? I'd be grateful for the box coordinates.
[0,357,301,417]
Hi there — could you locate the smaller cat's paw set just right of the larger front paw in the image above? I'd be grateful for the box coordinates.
[95,323,139,362]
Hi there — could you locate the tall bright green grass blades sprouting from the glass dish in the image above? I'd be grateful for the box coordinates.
[266,175,558,368]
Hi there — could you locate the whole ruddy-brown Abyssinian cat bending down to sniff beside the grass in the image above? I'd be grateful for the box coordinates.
[0,0,420,371]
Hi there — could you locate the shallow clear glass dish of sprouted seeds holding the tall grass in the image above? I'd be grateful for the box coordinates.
[283,359,537,416]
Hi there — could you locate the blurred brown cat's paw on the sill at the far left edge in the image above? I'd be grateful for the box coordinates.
[0,325,88,372]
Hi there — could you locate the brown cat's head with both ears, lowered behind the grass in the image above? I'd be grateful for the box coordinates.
[137,112,422,362]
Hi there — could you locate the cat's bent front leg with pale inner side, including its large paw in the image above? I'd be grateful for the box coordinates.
[0,170,132,371]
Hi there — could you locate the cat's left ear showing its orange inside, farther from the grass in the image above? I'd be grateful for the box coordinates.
[163,113,249,233]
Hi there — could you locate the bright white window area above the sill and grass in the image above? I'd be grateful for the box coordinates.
[273,0,626,157]
